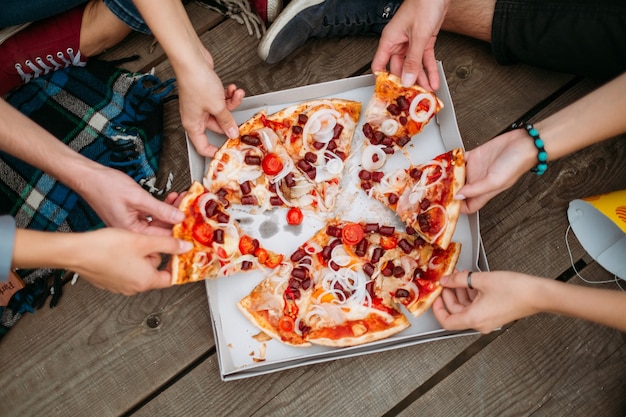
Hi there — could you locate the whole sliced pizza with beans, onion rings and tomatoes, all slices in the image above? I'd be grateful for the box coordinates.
[172,87,465,347]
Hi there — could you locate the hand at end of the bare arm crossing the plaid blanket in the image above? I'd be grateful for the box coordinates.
[80,166,185,236]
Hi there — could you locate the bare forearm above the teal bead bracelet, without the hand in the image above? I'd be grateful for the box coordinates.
[535,73,626,160]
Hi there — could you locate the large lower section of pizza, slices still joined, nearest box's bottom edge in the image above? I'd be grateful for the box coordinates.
[238,219,460,347]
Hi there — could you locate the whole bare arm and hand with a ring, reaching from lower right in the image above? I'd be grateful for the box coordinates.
[433,271,626,333]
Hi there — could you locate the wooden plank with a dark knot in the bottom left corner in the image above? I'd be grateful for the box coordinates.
[0,280,213,416]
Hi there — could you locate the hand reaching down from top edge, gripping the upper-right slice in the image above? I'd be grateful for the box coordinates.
[372,0,450,91]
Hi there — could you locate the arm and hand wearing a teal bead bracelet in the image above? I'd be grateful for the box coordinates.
[459,73,626,213]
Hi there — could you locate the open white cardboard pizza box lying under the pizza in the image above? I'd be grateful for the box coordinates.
[187,64,489,381]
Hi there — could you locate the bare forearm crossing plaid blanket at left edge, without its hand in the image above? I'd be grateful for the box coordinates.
[0,100,103,199]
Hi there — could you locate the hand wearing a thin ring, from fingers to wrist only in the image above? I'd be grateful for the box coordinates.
[433,271,542,333]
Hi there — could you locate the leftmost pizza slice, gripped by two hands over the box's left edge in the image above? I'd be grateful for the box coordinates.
[172,182,283,285]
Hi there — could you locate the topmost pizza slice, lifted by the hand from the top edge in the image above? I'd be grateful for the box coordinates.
[363,71,443,153]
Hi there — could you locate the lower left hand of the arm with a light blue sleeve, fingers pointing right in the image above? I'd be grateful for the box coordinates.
[68,228,193,295]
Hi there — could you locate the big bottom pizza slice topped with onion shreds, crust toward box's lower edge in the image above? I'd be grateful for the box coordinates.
[239,220,409,347]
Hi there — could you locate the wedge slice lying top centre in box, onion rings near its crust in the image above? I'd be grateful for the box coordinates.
[266,99,361,211]
